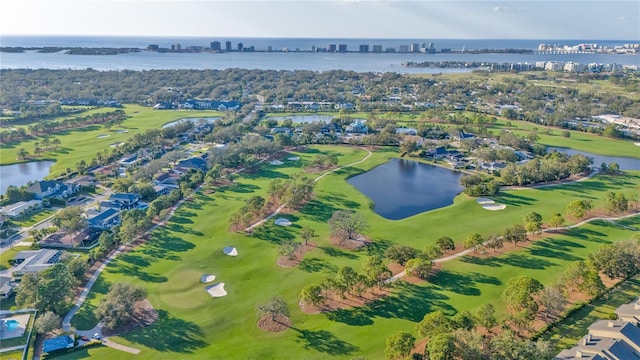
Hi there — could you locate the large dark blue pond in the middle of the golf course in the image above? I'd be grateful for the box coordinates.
[347,159,463,220]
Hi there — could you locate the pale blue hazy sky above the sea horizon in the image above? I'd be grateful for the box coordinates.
[0,0,640,42]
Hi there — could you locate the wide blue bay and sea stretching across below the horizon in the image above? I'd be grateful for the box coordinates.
[0,36,640,73]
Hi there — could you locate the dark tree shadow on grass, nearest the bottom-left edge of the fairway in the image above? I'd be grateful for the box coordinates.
[121,310,208,353]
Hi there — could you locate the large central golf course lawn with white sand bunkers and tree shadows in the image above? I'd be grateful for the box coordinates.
[65,146,640,359]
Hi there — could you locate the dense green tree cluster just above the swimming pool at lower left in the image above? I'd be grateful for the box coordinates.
[16,257,88,315]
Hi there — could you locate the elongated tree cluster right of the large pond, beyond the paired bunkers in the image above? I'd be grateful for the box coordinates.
[500,151,593,185]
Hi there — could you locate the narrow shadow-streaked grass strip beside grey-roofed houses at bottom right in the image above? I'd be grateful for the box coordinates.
[544,276,640,352]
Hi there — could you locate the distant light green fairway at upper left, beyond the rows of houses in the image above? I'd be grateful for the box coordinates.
[0,105,221,178]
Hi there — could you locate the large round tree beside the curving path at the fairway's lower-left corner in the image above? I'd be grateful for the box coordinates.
[94,283,147,329]
